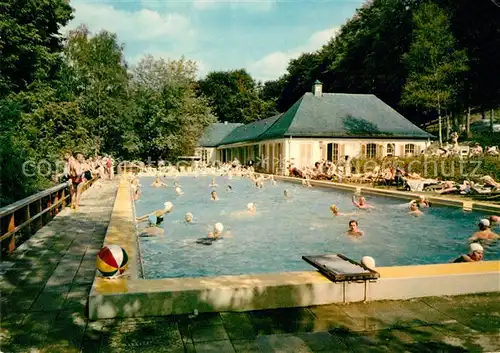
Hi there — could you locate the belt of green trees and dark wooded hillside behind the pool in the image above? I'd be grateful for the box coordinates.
[0,0,500,205]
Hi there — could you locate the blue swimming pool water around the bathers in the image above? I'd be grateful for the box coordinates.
[135,176,500,279]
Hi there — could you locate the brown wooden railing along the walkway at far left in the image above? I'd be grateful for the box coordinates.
[0,179,96,255]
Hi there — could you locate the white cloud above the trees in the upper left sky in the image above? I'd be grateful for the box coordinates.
[63,1,196,42]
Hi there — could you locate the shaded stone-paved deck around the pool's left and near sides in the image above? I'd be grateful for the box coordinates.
[0,181,500,353]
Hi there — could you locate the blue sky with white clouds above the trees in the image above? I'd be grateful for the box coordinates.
[62,0,364,81]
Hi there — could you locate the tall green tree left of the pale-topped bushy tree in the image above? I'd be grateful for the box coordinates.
[65,26,135,153]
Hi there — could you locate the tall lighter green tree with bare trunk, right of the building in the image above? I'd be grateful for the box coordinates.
[403,3,468,143]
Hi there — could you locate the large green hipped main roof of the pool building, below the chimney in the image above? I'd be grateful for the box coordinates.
[258,93,434,140]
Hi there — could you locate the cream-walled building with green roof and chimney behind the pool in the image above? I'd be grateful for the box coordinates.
[200,81,434,174]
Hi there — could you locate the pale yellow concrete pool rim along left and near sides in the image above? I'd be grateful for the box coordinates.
[88,176,500,320]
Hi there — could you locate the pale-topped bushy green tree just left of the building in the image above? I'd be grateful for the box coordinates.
[132,56,215,160]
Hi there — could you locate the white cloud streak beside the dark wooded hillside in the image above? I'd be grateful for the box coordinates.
[248,27,339,81]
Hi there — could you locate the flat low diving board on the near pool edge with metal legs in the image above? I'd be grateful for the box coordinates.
[302,254,380,282]
